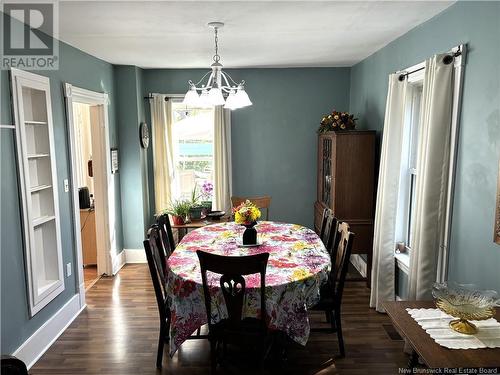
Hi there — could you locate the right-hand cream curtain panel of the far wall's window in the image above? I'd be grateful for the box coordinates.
[212,106,232,212]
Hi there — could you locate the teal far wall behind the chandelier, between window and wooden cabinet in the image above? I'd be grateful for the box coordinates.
[144,68,350,227]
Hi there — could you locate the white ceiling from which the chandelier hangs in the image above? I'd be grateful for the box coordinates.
[59,1,453,68]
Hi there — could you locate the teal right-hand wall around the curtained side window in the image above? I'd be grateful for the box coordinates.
[350,2,500,291]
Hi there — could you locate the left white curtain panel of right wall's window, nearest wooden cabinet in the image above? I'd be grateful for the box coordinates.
[370,74,407,312]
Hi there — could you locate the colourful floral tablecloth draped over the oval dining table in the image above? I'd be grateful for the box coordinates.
[167,221,330,355]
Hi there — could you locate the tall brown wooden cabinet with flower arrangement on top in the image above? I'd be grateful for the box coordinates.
[314,130,375,284]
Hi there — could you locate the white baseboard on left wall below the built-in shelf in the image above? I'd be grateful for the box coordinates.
[13,294,85,369]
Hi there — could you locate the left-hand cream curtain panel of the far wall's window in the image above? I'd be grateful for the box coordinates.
[151,94,174,213]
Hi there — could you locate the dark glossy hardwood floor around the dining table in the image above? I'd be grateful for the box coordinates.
[30,264,408,375]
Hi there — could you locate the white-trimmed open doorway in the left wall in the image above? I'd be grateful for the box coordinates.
[64,83,116,307]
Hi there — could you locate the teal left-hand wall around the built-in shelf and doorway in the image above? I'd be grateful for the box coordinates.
[0,14,122,353]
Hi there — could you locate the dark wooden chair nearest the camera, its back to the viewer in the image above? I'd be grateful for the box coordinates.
[196,250,269,374]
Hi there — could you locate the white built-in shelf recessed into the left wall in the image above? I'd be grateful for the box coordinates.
[11,69,64,316]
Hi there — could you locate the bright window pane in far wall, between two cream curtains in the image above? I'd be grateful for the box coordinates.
[172,101,214,199]
